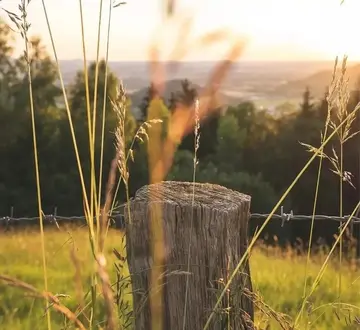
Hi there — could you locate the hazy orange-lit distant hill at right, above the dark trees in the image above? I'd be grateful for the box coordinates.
[273,64,360,98]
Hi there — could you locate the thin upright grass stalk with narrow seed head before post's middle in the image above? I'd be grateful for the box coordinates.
[183,99,200,330]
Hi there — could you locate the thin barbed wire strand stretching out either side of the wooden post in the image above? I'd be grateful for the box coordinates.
[0,205,360,228]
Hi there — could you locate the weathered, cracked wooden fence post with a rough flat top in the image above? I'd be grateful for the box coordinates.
[125,181,254,330]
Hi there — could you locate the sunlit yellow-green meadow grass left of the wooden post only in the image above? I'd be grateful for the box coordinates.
[0,227,128,329]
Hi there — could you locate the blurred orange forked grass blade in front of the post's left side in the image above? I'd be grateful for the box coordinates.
[144,9,248,330]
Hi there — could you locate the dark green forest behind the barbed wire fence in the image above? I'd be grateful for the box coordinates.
[0,24,360,245]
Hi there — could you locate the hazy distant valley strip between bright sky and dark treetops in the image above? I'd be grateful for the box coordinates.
[60,60,360,107]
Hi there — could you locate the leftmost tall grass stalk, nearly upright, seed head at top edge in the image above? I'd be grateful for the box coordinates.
[19,0,51,330]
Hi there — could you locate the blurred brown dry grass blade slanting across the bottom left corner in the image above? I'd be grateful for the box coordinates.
[0,275,85,330]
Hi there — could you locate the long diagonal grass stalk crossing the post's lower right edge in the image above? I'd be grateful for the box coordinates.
[203,101,359,330]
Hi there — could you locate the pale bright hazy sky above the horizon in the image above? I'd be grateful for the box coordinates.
[0,0,360,60]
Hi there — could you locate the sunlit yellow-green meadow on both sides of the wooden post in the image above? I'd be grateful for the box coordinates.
[0,229,360,330]
